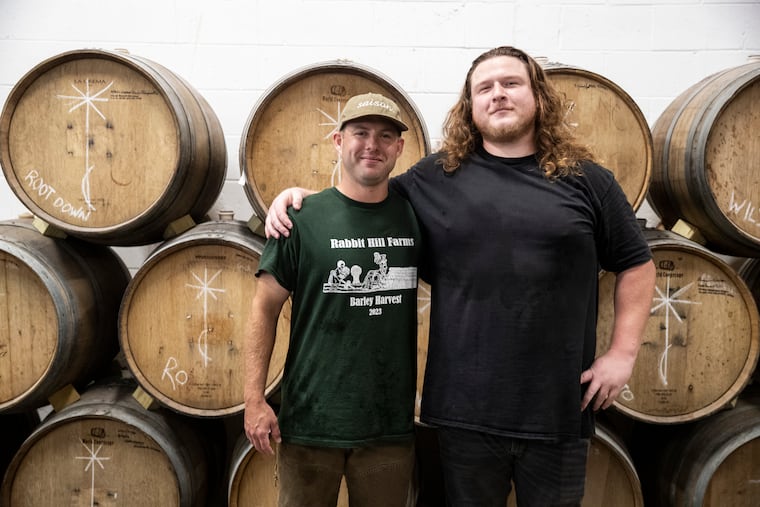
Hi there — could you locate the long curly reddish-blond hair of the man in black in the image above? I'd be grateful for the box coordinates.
[439,46,595,178]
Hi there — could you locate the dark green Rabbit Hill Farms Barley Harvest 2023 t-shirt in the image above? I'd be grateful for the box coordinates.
[259,188,421,447]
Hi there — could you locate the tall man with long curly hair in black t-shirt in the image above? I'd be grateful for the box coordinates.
[267,47,655,507]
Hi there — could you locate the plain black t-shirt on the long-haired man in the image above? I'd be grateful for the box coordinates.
[391,149,651,439]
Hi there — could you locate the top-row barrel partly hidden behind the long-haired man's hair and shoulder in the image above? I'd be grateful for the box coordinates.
[542,62,653,210]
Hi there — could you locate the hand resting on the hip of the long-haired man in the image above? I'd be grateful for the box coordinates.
[581,350,636,411]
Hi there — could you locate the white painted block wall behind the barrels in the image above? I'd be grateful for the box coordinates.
[0,0,760,269]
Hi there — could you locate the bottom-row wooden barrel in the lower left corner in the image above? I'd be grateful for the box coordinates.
[0,382,213,507]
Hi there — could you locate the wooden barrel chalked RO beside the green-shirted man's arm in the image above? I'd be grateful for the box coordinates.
[118,220,290,417]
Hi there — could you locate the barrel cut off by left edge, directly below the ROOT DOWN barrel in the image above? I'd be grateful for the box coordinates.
[0,219,129,411]
